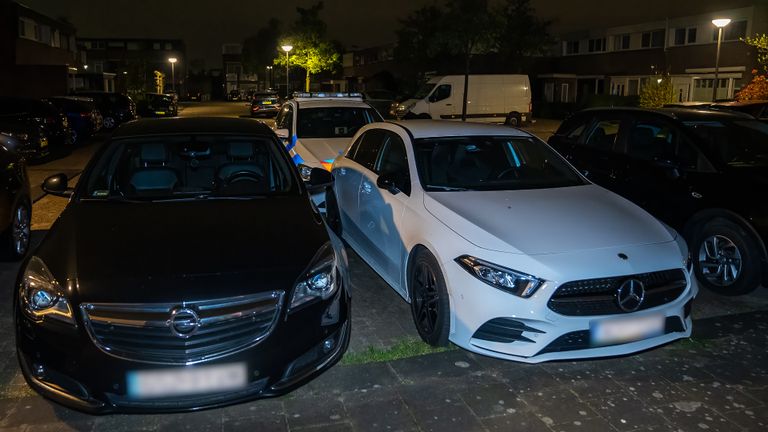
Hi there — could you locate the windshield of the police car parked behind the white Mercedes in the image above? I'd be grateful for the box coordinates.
[296,107,382,138]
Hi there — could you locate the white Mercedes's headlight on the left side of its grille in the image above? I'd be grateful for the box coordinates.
[456,255,544,298]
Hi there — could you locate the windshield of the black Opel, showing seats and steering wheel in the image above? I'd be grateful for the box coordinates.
[82,135,293,201]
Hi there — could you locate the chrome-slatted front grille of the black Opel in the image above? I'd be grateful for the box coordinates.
[80,291,283,364]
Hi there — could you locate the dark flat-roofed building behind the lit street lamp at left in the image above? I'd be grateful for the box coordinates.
[77,38,188,95]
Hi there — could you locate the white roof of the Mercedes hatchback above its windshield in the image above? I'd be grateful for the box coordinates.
[392,120,531,139]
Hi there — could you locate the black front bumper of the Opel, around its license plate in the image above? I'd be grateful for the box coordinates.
[16,289,351,414]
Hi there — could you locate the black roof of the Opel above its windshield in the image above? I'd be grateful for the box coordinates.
[112,117,273,138]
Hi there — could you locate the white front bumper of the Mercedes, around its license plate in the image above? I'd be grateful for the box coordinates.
[445,255,698,363]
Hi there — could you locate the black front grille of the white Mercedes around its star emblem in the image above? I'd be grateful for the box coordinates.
[547,269,688,316]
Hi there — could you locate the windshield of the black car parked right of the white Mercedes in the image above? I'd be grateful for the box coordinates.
[685,120,768,166]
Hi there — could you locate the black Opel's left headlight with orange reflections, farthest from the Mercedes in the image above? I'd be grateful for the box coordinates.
[19,256,75,324]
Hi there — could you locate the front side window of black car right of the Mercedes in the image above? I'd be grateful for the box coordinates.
[627,120,677,161]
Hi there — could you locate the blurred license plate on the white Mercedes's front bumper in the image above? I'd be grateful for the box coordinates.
[590,314,665,345]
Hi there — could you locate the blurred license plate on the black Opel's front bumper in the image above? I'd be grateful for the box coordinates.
[127,363,248,399]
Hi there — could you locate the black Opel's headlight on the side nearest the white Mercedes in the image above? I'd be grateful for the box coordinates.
[288,243,340,311]
